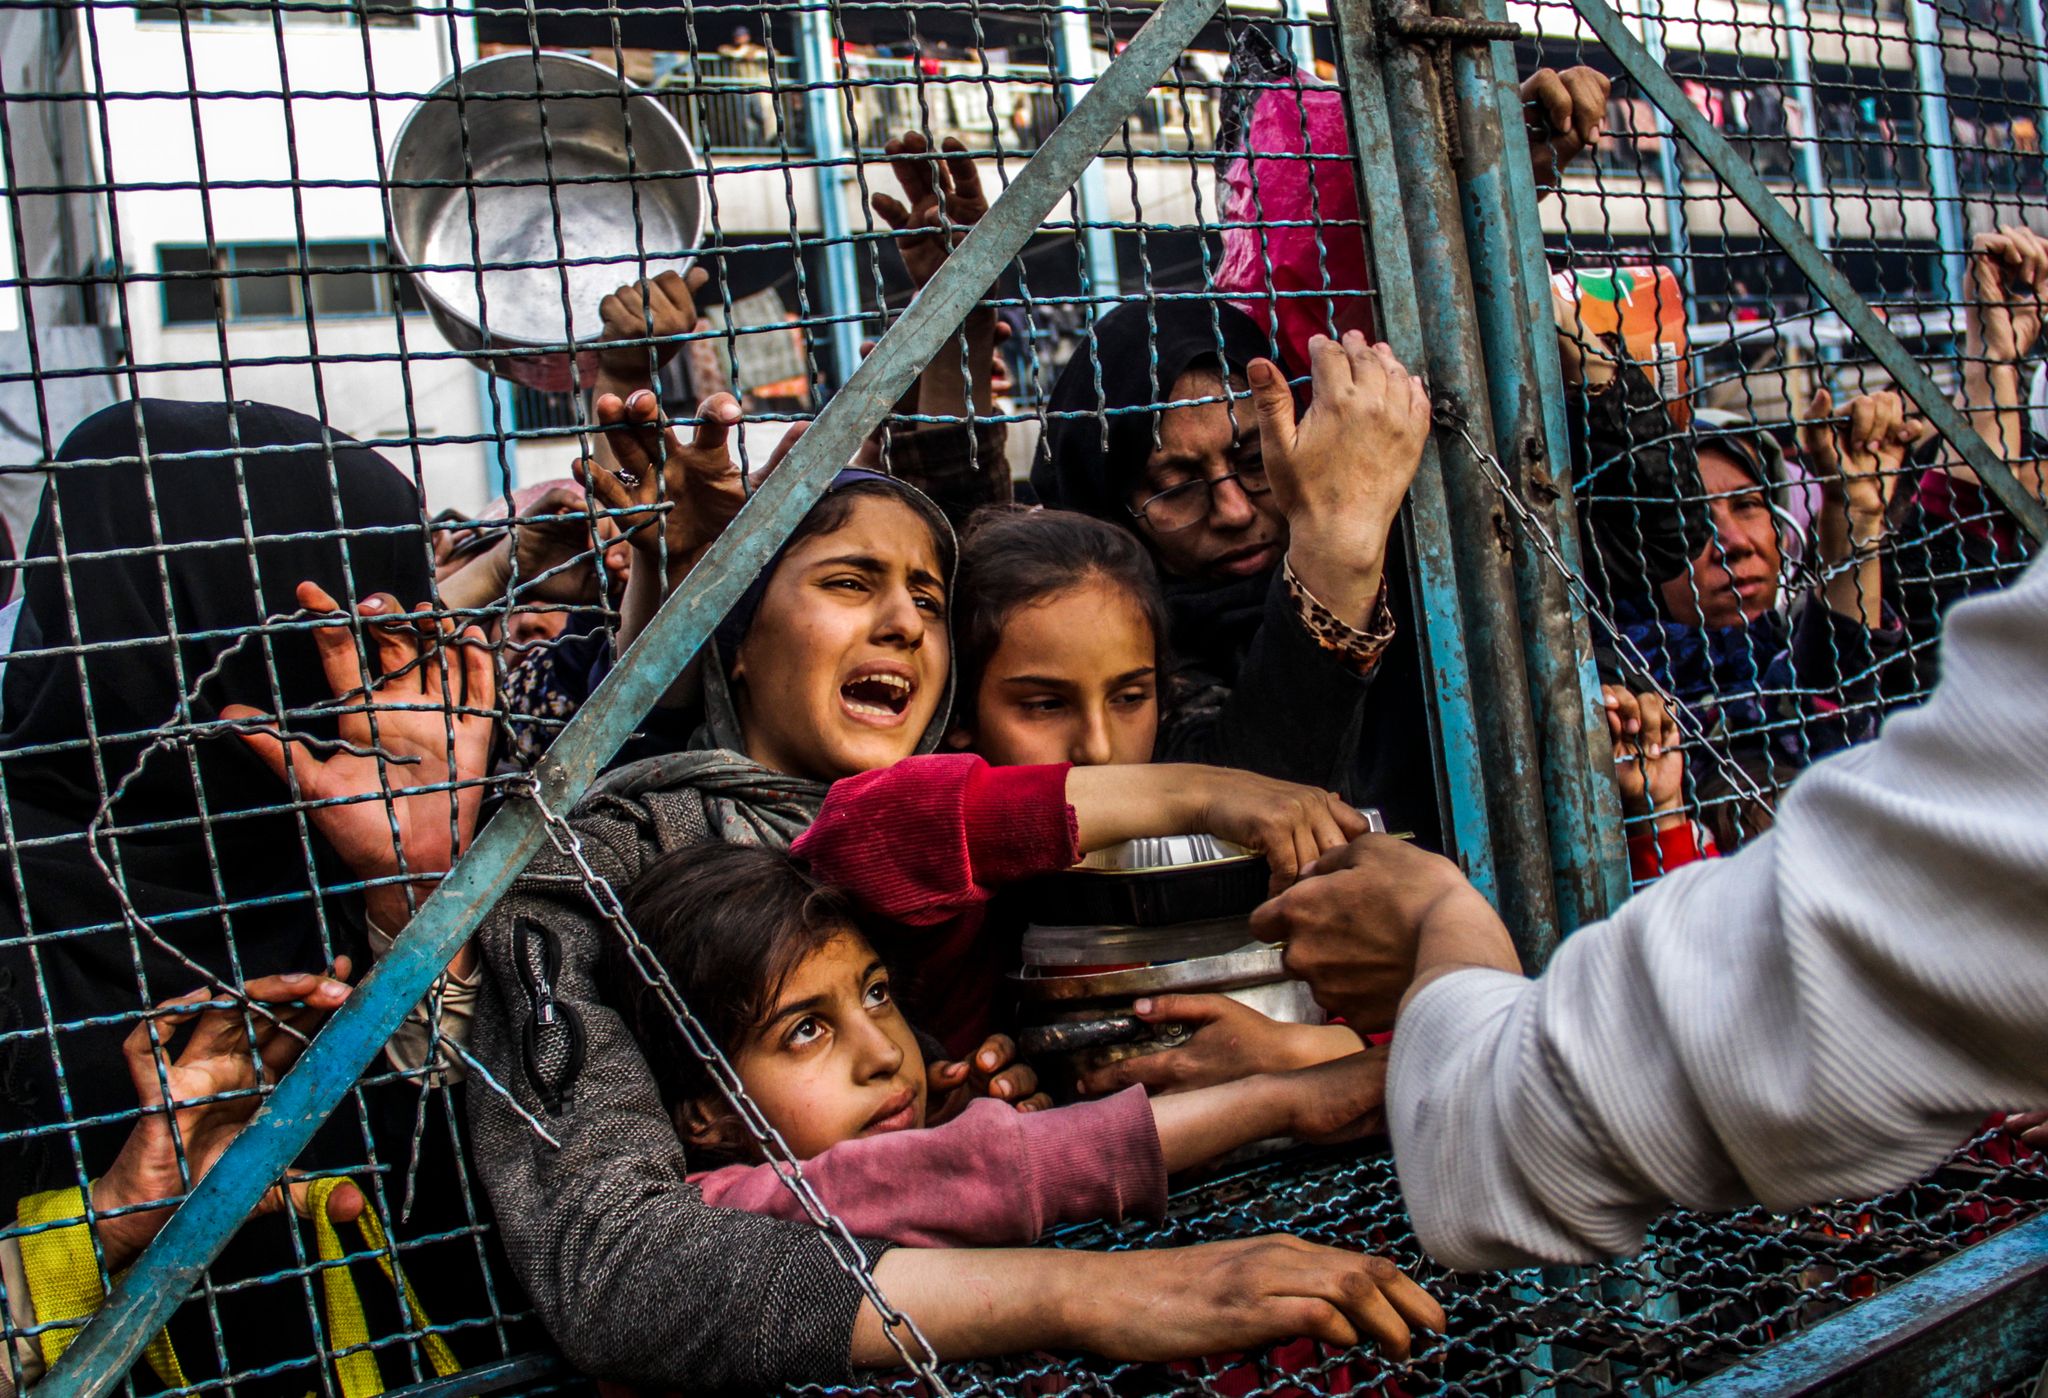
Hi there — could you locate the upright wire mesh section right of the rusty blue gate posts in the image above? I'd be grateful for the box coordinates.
[1522,4,2048,876]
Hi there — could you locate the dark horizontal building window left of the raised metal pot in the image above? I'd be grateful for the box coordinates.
[156,239,424,325]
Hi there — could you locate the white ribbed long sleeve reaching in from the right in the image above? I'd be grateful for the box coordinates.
[1389,563,2048,1267]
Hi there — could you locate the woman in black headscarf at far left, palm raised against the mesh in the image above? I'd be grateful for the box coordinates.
[0,399,503,1392]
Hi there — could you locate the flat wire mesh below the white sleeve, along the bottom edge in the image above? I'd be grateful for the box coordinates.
[797,1136,2044,1396]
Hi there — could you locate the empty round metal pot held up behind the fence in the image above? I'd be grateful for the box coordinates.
[391,53,705,393]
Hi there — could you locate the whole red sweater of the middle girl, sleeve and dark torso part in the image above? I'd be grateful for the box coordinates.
[791,753,1081,1058]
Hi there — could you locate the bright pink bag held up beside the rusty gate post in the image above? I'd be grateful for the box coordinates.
[1214,76,1376,377]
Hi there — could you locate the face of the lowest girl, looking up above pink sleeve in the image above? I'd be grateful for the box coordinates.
[733,931,926,1161]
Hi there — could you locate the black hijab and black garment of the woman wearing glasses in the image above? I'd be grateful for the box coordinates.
[1032,297,1438,839]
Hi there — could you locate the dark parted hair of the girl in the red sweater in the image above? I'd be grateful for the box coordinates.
[952,506,1167,716]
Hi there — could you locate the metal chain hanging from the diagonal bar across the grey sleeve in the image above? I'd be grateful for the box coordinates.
[512,776,952,1398]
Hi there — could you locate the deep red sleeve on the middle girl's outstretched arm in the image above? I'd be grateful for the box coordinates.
[791,753,1081,927]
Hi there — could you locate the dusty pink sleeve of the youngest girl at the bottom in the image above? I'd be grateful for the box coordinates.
[690,1087,1165,1247]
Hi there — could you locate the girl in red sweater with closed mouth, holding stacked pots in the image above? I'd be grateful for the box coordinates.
[791,510,1364,1099]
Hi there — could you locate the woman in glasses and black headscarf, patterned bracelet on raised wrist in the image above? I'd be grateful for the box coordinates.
[1032,299,1436,833]
